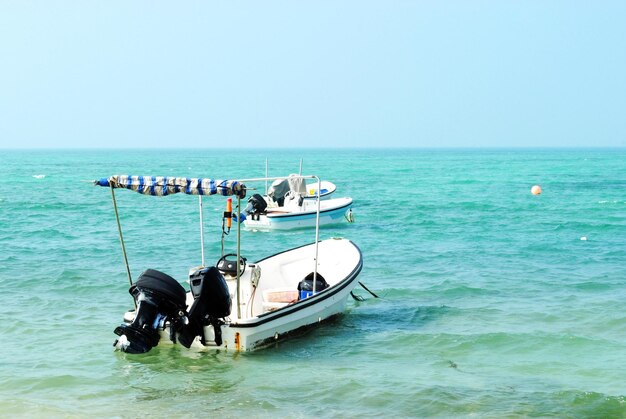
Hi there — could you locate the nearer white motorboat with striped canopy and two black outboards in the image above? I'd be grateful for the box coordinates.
[94,176,363,353]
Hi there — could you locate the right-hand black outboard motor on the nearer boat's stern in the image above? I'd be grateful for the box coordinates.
[178,266,232,348]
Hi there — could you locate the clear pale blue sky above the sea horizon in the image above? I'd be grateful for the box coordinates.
[0,0,626,148]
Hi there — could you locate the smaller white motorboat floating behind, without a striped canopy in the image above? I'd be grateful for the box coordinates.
[237,175,353,230]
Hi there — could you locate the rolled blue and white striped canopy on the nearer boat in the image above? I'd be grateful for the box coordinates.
[94,175,246,198]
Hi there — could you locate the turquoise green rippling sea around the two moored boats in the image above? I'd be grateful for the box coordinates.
[0,148,626,418]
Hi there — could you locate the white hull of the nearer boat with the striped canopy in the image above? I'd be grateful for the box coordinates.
[125,239,363,352]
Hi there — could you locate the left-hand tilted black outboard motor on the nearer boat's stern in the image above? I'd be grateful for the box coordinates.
[114,269,187,354]
